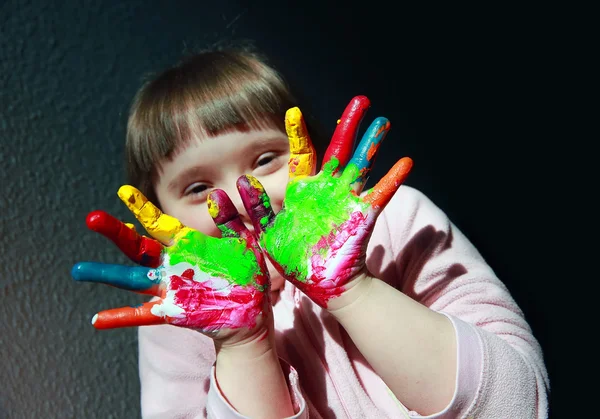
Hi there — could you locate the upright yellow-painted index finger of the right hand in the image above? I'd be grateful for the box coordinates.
[285,107,317,179]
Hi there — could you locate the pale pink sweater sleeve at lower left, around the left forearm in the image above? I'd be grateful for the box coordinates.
[138,325,308,419]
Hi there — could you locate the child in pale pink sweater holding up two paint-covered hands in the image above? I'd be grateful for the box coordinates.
[73,49,549,418]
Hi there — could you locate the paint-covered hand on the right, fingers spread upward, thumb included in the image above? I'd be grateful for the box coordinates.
[238,96,412,308]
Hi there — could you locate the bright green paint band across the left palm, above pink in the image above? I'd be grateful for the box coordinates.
[166,230,260,286]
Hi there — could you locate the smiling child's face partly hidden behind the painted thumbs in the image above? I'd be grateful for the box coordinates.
[154,128,289,291]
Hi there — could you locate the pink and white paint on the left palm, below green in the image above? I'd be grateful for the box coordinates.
[170,269,263,332]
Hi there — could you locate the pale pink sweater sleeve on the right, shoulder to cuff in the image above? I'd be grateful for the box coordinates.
[369,186,549,419]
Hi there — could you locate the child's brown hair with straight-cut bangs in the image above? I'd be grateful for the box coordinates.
[125,48,308,205]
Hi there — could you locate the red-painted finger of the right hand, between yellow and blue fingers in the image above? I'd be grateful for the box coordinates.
[321,96,371,174]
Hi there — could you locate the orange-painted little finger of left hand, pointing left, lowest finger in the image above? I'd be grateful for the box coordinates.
[92,301,167,329]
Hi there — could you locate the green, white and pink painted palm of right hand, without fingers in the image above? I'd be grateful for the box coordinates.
[261,157,376,307]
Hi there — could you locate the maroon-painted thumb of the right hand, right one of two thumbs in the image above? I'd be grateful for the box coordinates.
[237,175,275,233]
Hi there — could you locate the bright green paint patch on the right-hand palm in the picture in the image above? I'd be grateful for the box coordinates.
[261,158,369,281]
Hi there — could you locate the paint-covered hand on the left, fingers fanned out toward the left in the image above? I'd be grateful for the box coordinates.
[72,185,270,339]
